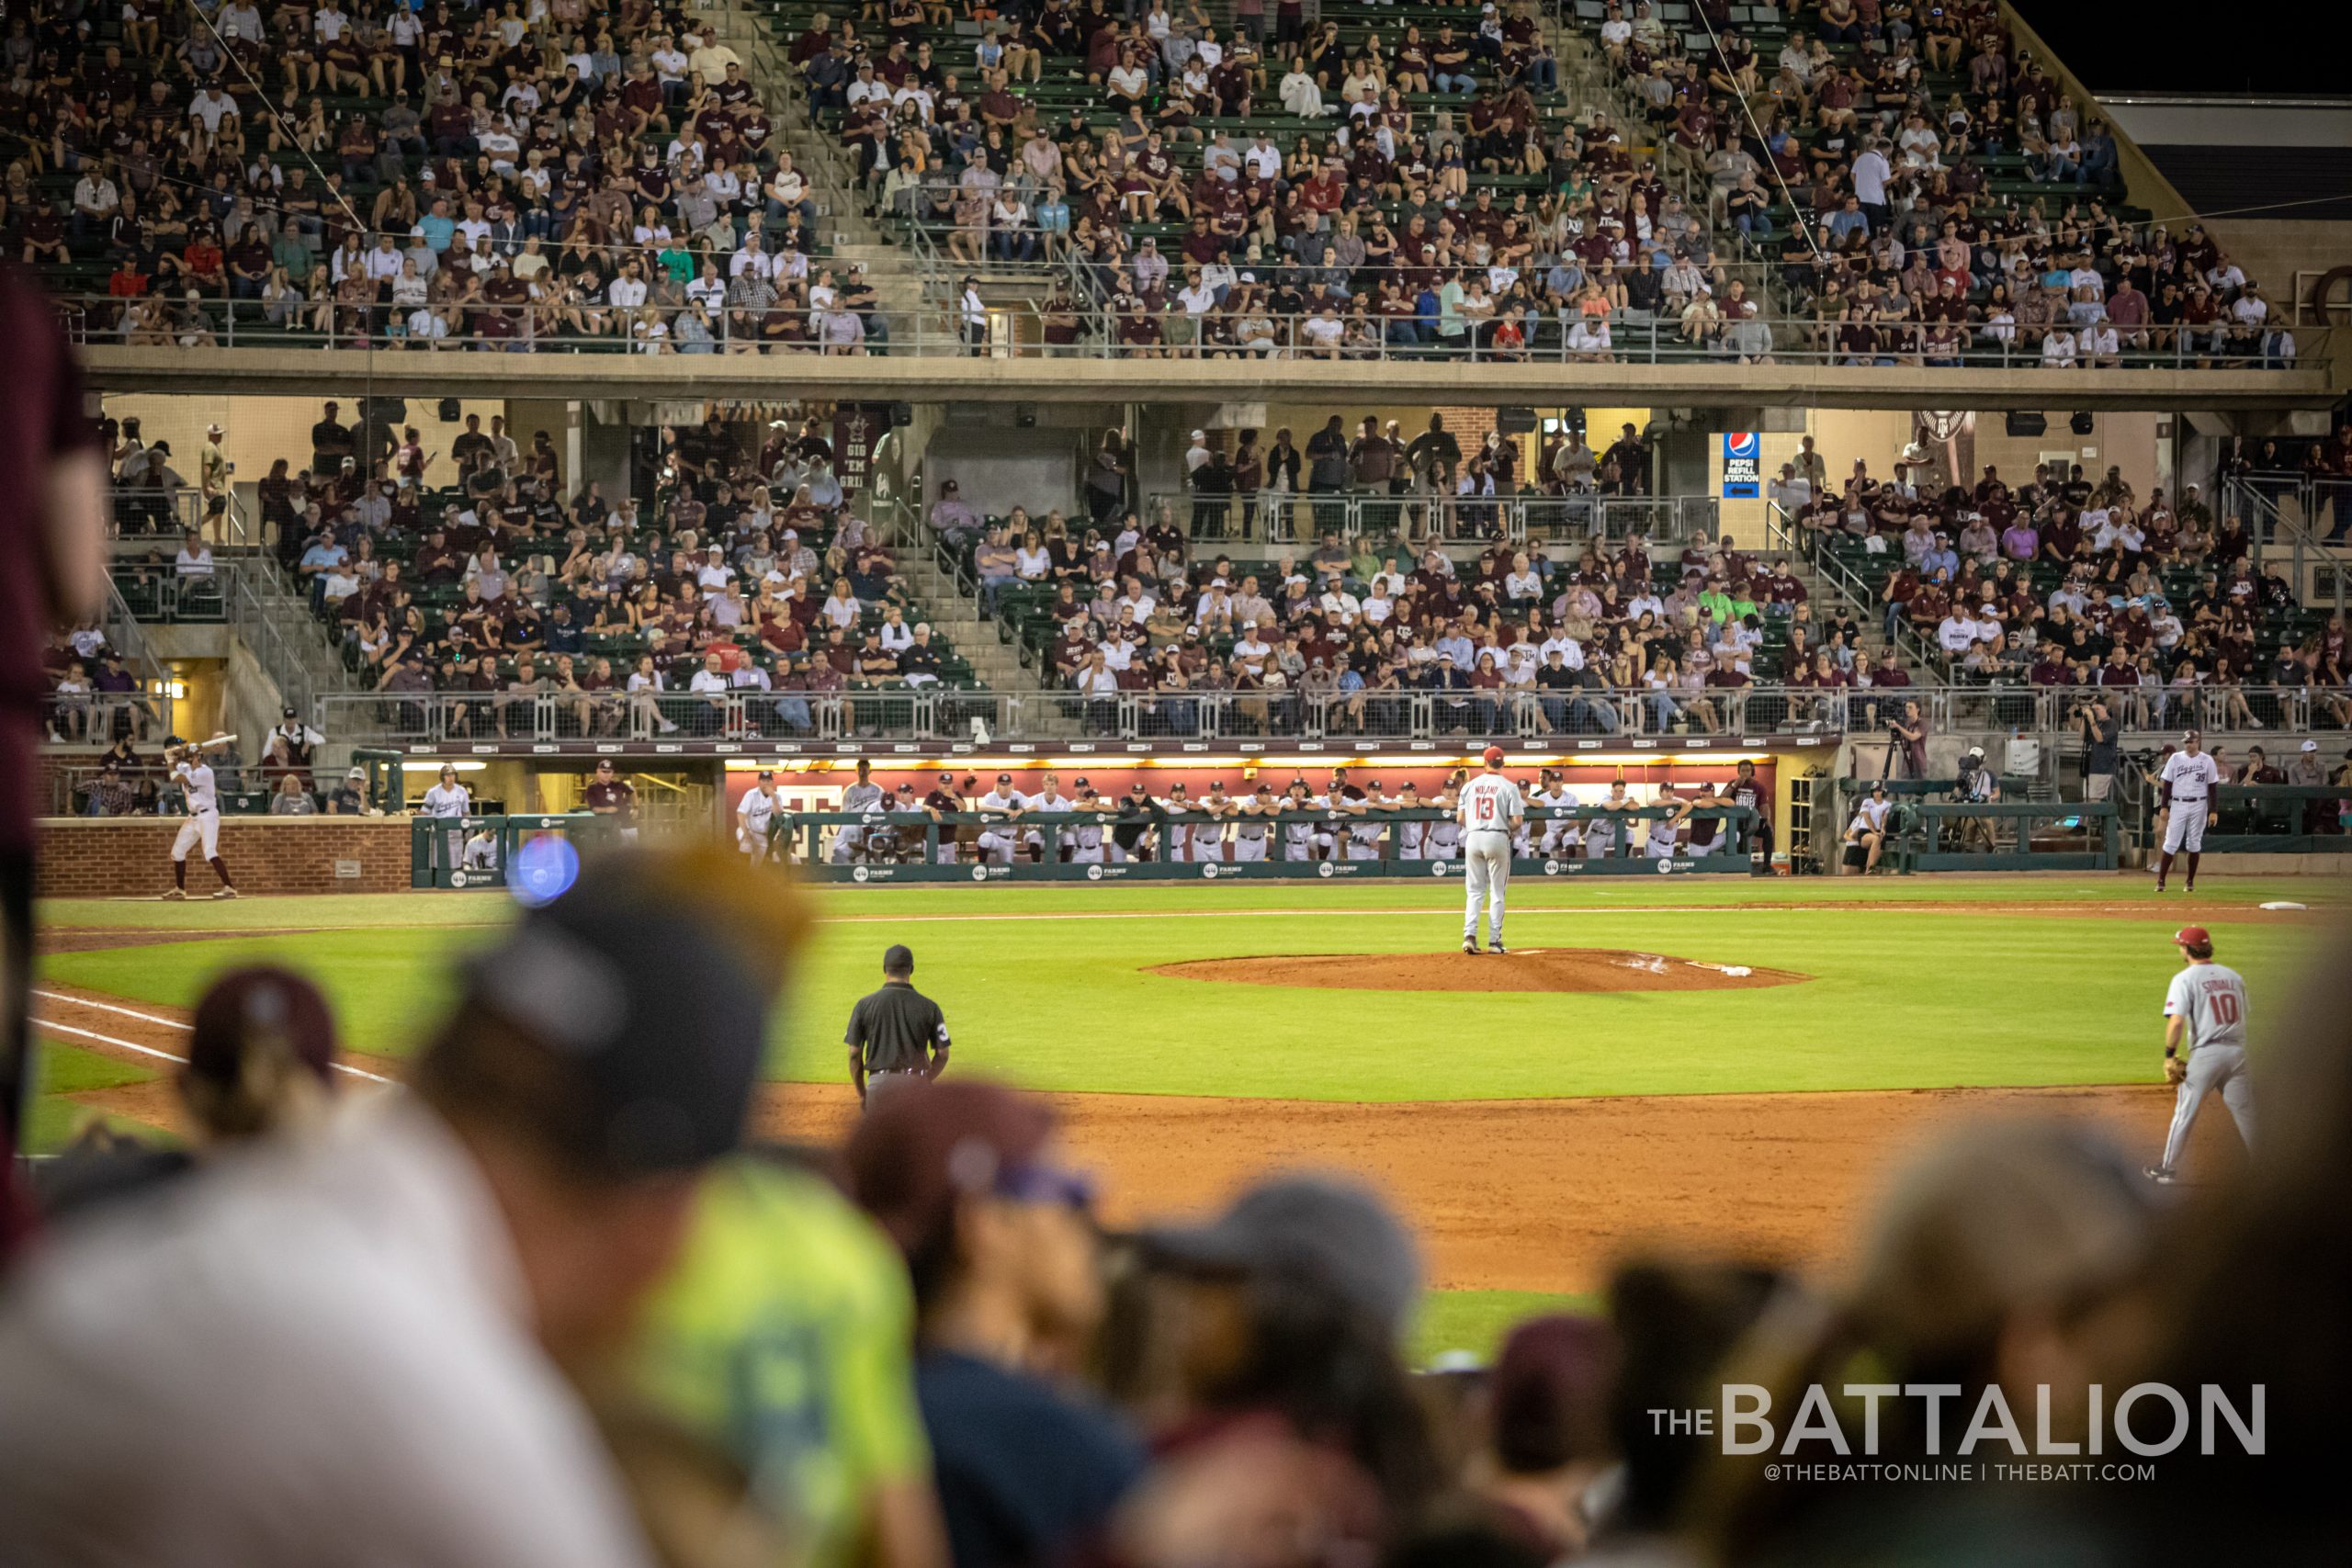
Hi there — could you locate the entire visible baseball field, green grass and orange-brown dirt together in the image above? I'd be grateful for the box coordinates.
[38,874,2328,1306]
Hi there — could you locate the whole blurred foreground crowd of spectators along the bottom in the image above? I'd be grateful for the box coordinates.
[0,849,2352,1568]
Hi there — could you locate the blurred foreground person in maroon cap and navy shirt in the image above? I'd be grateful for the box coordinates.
[849,1081,1143,1568]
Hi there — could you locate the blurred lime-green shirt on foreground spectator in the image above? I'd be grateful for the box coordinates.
[635,1159,932,1568]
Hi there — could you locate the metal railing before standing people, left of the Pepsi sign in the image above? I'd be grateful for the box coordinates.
[1143,489,1722,547]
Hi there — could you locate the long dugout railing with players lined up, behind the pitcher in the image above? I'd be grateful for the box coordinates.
[769,804,1757,884]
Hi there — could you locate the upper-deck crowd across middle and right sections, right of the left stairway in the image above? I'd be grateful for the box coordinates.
[766,0,2296,367]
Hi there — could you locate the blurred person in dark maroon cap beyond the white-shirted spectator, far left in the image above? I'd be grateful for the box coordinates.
[38,966,336,1223]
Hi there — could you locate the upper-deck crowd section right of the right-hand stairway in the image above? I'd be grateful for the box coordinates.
[1588,0,2296,369]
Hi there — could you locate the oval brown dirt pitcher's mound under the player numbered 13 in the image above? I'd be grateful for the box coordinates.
[1146,947,1814,992]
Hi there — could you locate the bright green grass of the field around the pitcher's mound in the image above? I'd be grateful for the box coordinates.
[42,877,2340,1100]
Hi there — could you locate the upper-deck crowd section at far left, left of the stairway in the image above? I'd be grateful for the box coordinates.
[18,0,889,353]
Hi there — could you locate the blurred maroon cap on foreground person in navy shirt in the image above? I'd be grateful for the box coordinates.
[847,1079,1091,1248]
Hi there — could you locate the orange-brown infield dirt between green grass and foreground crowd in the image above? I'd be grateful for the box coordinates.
[38,982,2242,1291]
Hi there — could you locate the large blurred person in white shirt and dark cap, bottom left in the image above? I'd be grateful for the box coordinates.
[0,846,805,1568]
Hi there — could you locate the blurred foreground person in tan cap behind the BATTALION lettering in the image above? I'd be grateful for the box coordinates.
[1701,1122,2157,1565]
